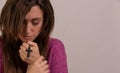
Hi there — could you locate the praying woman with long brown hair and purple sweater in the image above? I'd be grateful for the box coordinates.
[0,0,68,73]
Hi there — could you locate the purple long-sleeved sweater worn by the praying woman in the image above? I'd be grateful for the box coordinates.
[0,38,68,73]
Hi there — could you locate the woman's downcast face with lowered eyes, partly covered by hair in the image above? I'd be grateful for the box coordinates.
[19,6,43,42]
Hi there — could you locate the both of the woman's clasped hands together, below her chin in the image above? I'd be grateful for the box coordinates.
[19,41,50,73]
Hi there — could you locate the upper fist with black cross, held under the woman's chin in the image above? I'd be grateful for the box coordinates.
[19,41,40,64]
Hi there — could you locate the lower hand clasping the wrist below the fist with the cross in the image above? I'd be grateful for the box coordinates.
[26,56,50,73]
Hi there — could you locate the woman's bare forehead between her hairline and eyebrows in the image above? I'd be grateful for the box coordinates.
[25,6,43,20]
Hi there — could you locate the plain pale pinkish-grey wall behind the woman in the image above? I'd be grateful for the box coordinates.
[0,0,120,73]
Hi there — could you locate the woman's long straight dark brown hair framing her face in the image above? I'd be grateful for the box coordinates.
[0,0,54,73]
